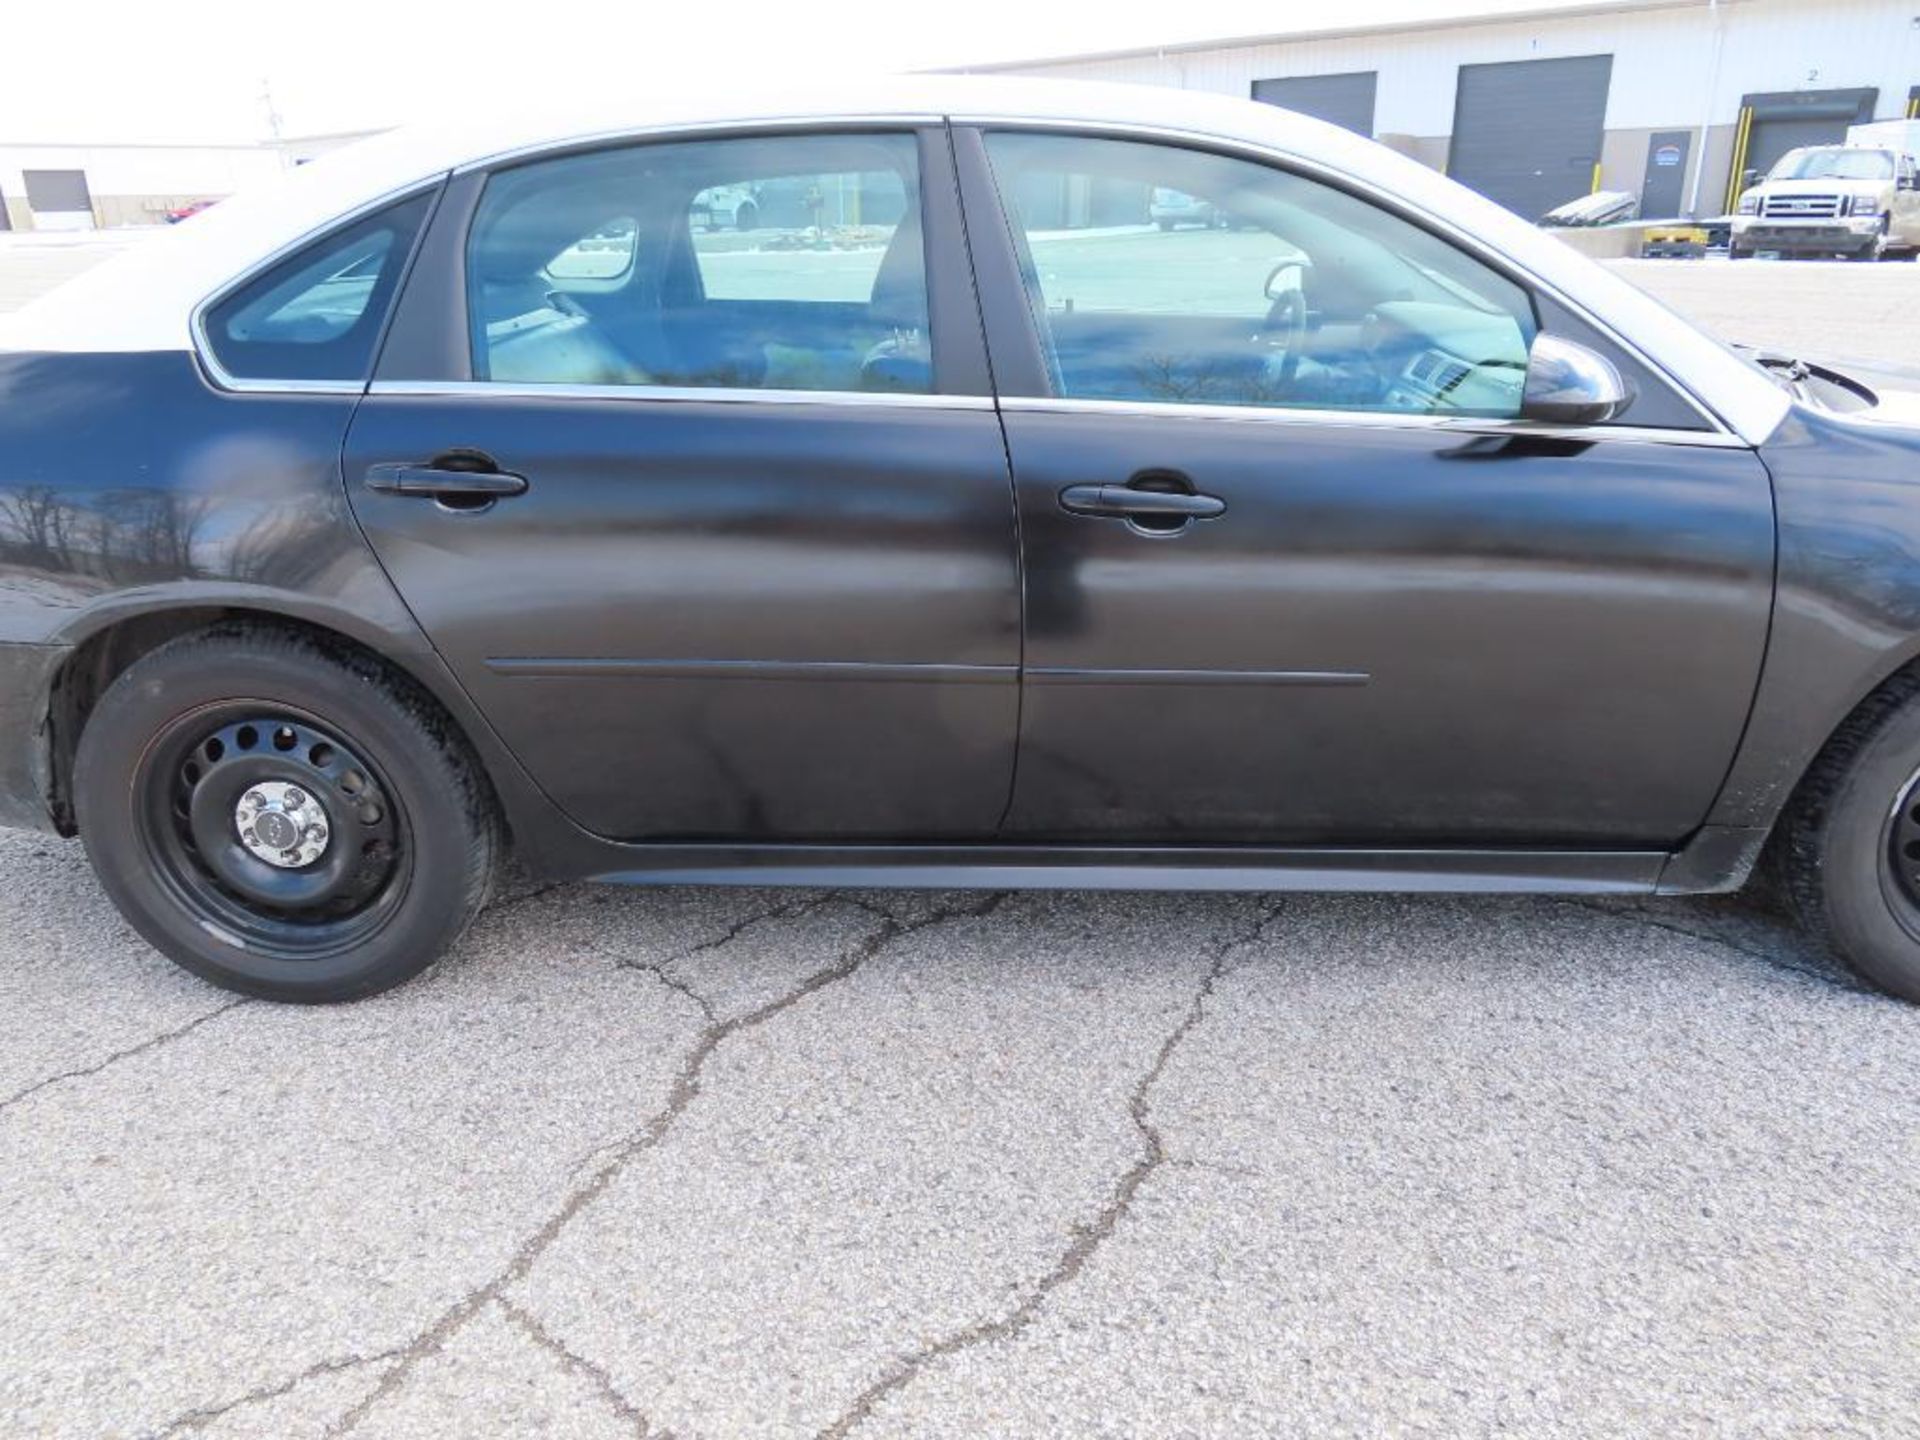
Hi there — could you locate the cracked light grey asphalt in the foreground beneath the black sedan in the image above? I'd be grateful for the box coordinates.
[11,253,1920,1440]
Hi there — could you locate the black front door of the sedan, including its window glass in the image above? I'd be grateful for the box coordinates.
[958,131,1774,849]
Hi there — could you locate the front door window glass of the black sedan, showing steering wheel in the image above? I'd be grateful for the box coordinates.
[987,134,1538,417]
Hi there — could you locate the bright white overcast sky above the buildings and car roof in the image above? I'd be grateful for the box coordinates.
[0,0,1628,144]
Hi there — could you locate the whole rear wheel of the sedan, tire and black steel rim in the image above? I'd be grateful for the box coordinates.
[73,626,503,1004]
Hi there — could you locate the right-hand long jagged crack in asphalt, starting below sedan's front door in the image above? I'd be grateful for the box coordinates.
[818,900,1281,1440]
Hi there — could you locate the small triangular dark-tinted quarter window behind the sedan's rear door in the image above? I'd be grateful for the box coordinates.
[205,196,428,380]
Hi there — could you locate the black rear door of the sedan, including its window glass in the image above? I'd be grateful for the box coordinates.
[344,131,1020,841]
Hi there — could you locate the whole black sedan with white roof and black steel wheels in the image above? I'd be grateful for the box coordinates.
[0,79,1920,1000]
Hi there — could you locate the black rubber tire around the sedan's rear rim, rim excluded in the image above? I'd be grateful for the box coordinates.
[75,639,484,1000]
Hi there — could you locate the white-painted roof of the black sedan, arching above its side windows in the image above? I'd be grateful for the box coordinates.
[0,75,1786,442]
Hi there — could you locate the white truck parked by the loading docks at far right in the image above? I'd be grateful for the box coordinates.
[1728,121,1920,259]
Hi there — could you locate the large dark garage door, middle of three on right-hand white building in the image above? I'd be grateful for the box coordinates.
[1446,56,1613,219]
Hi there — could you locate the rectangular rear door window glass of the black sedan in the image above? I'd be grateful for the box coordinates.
[467,134,933,392]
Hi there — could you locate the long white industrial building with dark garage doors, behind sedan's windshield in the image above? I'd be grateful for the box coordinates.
[970,0,1920,217]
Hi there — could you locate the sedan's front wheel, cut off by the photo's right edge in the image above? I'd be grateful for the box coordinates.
[1778,678,1920,1000]
